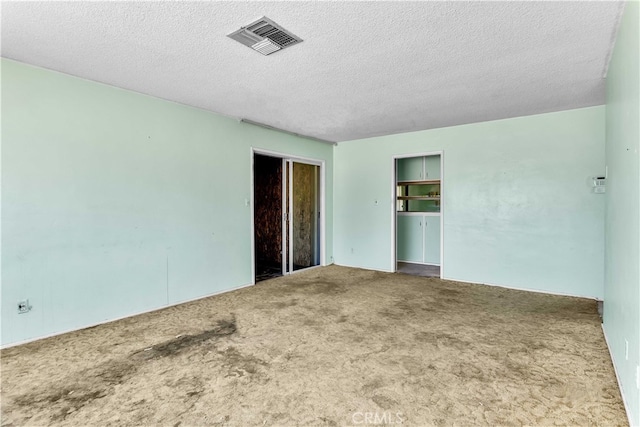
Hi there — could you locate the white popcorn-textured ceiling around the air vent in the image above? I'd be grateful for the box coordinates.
[2,1,623,141]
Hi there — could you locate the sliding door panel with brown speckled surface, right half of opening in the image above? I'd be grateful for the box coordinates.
[289,162,320,271]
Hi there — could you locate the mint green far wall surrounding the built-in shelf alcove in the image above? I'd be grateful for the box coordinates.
[334,106,605,298]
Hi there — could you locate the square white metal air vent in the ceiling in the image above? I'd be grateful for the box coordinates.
[227,16,302,55]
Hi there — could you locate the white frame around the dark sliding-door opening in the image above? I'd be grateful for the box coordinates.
[249,147,327,285]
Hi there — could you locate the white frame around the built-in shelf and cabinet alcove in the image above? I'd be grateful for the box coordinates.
[391,150,445,278]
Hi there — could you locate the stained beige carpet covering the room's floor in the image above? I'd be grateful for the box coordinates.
[1,266,626,426]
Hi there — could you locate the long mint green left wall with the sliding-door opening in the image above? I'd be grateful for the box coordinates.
[1,59,333,345]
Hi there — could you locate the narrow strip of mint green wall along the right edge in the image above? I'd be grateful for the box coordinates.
[604,1,640,426]
